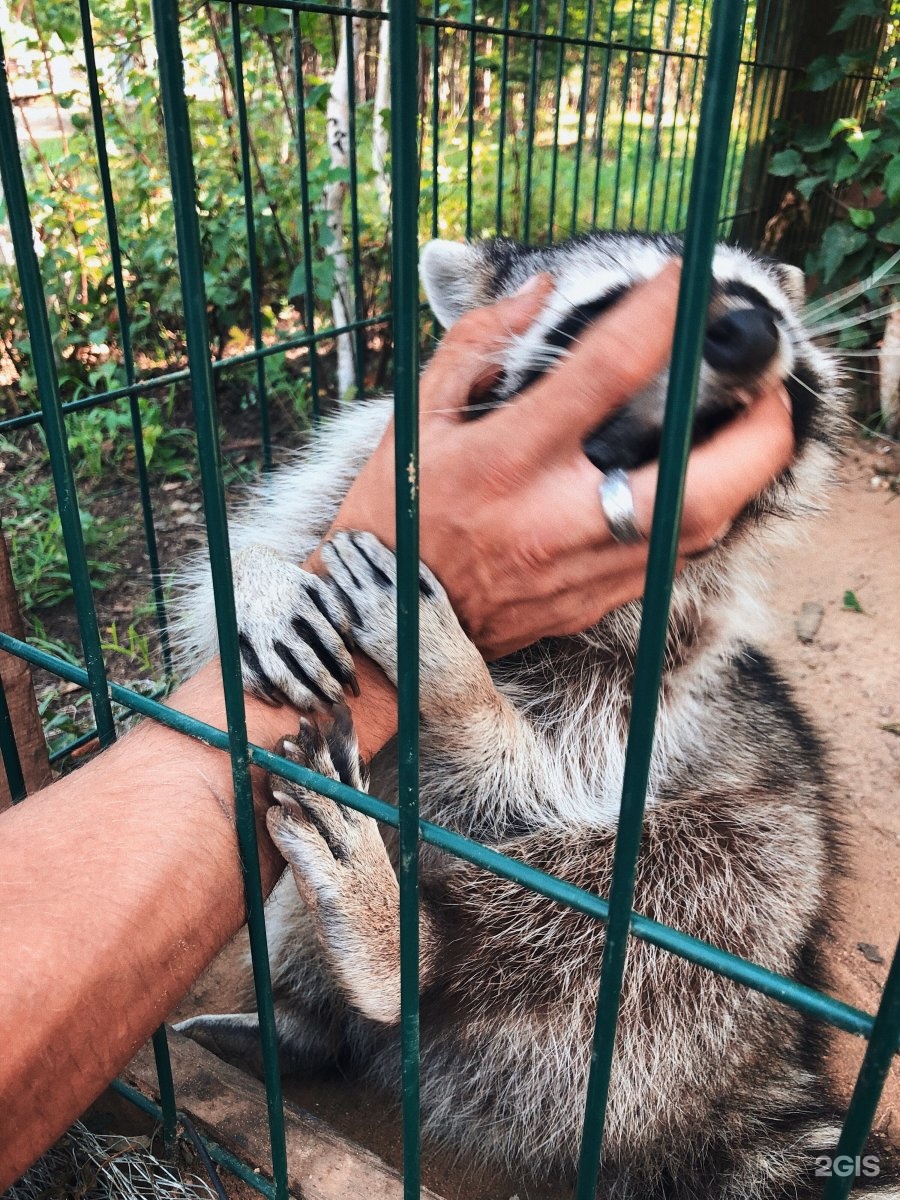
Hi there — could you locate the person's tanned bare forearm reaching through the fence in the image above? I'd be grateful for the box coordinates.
[0,661,396,1190]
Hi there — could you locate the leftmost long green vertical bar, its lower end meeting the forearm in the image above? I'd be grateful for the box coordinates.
[0,25,115,746]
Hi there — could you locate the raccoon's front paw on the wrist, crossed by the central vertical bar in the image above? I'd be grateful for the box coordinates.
[322,530,453,683]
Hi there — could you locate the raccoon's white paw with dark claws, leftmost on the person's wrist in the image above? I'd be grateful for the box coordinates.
[234,546,359,710]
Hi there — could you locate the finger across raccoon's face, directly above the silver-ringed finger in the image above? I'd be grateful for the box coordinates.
[486,260,682,469]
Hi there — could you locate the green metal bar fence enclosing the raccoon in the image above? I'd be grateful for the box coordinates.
[0,0,900,1200]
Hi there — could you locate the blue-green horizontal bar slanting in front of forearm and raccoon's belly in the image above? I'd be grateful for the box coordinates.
[0,632,900,1052]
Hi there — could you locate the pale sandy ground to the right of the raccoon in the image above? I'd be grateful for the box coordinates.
[769,442,900,1142]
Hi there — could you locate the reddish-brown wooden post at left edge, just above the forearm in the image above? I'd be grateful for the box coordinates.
[0,532,52,811]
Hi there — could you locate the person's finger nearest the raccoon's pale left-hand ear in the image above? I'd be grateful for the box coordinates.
[419,272,553,419]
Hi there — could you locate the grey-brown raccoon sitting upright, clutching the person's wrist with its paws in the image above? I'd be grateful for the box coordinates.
[172,233,900,1200]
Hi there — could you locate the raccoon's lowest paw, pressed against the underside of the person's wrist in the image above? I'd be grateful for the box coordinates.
[265,704,385,902]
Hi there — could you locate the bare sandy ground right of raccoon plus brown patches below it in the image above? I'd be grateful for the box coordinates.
[172,442,900,1200]
